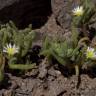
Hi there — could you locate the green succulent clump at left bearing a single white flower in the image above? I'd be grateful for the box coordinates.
[0,21,36,81]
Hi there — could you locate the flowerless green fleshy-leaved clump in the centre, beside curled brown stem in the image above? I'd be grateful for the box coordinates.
[41,37,88,76]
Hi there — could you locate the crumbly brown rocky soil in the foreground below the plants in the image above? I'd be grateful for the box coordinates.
[0,59,96,96]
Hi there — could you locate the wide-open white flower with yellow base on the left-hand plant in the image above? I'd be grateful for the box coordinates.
[3,44,19,55]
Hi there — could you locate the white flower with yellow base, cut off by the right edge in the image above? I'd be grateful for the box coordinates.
[86,47,96,59]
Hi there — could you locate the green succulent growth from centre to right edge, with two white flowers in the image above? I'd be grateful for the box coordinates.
[41,0,96,76]
